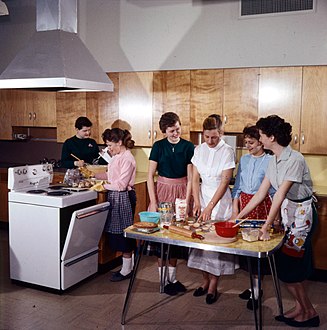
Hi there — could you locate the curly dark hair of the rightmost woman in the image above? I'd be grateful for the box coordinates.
[256,115,292,147]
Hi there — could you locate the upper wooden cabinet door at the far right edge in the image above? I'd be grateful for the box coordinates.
[300,66,327,155]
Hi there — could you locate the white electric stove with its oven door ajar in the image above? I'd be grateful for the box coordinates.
[8,164,109,290]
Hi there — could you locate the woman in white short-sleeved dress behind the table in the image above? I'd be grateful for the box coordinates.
[188,115,235,304]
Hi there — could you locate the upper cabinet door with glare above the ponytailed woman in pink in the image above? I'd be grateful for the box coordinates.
[119,72,153,146]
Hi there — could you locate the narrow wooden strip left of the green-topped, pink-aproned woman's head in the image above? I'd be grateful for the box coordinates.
[152,71,167,142]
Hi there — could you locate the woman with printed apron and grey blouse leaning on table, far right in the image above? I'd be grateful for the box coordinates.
[237,115,320,327]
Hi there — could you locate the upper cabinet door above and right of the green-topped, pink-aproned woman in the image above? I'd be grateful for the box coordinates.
[164,70,191,140]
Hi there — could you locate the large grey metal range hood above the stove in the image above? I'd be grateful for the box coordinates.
[0,0,114,91]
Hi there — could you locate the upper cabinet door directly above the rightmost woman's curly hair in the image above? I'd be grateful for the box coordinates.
[259,67,302,149]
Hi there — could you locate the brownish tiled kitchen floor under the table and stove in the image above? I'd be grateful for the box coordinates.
[0,230,327,330]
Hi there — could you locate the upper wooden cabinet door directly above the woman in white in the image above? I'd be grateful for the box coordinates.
[190,70,224,131]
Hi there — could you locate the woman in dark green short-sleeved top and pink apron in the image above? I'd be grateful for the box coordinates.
[147,112,194,295]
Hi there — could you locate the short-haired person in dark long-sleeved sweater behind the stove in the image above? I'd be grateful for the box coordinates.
[61,117,106,168]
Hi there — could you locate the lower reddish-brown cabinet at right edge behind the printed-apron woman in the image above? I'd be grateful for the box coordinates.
[312,196,327,270]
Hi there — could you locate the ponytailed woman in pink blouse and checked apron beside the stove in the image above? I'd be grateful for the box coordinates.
[96,128,136,282]
